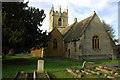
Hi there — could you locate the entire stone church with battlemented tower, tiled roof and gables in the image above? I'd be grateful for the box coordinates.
[45,6,116,59]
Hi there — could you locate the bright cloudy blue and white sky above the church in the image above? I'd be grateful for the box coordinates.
[25,0,119,38]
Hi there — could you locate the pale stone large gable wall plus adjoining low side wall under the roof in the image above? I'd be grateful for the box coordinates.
[66,15,115,59]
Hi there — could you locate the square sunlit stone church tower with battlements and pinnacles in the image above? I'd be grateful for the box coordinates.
[48,6,68,32]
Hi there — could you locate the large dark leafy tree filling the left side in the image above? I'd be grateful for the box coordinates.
[2,2,47,53]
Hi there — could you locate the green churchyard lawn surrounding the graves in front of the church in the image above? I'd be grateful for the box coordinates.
[2,56,120,78]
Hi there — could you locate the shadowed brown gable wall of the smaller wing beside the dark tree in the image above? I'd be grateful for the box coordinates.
[45,28,63,56]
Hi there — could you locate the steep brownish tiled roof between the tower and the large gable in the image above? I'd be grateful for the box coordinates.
[63,13,96,42]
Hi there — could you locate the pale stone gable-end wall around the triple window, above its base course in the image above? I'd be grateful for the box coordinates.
[83,15,113,59]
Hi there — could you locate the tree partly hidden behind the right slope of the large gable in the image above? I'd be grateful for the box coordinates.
[102,20,118,42]
